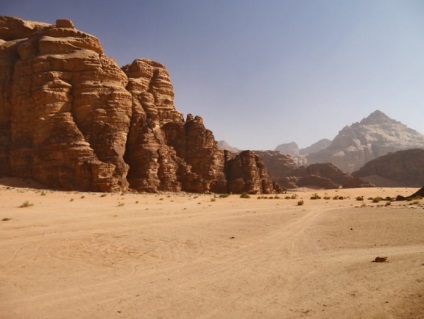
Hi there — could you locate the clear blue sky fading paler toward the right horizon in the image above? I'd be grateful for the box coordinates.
[0,0,424,149]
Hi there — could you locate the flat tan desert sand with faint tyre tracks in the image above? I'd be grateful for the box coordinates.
[0,180,424,319]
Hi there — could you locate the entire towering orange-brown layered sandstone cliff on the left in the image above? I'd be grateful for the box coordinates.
[0,17,273,193]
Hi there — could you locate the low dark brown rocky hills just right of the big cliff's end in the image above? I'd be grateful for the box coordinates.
[255,151,372,189]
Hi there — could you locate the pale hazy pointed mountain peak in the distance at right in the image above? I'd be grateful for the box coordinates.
[307,110,424,172]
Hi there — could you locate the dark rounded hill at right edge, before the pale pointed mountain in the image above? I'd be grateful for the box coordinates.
[353,149,424,187]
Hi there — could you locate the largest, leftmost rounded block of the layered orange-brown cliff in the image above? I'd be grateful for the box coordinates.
[0,18,132,191]
